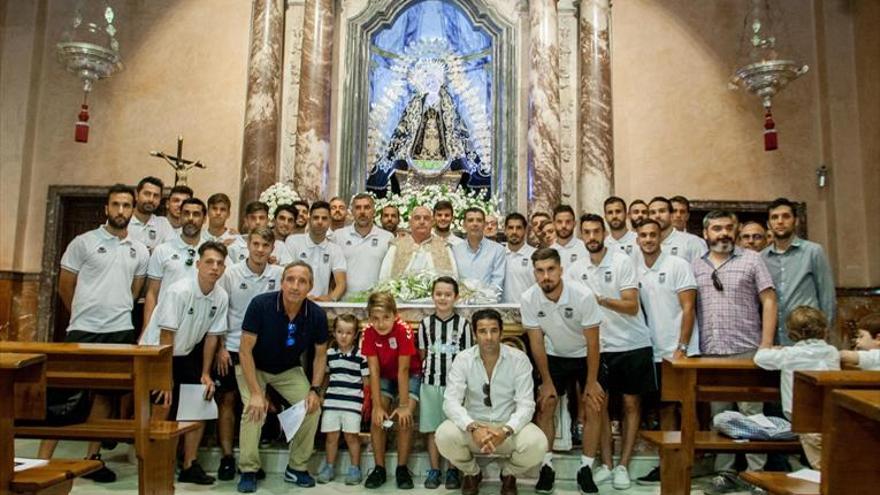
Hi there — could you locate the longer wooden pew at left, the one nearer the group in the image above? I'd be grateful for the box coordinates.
[0,342,201,494]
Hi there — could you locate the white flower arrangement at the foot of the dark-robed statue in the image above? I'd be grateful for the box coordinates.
[368,184,500,232]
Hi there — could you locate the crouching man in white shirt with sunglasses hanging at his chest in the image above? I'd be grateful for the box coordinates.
[436,309,547,495]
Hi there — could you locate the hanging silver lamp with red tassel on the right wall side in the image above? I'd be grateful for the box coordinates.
[730,0,809,151]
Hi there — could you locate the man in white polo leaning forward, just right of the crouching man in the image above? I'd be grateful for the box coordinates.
[520,248,604,494]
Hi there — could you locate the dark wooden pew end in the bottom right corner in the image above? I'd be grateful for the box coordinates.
[822,389,880,495]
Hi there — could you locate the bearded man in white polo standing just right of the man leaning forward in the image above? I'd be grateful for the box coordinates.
[568,213,657,490]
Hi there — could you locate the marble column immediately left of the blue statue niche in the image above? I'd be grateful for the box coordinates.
[293,0,333,201]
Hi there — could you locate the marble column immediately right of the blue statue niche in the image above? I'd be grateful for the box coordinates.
[528,0,562,211]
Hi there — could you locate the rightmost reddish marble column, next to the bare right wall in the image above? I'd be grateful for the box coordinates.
[578,0,614,214]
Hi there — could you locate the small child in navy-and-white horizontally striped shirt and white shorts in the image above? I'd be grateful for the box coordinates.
[318,314,370,485]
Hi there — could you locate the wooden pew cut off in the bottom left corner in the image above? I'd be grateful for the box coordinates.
[0,353,101,495]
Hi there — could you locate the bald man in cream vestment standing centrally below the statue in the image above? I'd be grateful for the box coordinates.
[379,206,458,280]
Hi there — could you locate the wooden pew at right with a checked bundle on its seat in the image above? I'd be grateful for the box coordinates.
[641,358,800,495]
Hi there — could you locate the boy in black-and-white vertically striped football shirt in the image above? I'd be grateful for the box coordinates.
[418,277,473,490]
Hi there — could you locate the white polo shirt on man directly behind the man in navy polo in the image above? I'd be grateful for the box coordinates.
[217,262,284,352]
